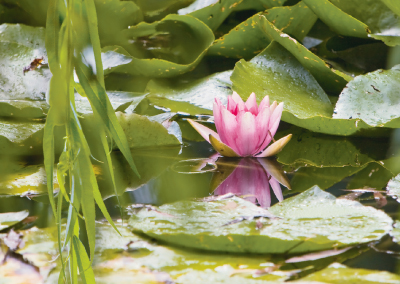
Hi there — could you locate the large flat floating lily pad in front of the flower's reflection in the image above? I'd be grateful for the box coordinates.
[129,186,392,253]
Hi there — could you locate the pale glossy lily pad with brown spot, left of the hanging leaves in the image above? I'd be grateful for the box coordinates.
[0,24,51,118]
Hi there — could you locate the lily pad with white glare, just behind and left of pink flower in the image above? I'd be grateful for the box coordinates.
[146,71,232,115]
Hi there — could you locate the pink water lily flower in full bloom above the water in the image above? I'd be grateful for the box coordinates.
[188,92,292,157]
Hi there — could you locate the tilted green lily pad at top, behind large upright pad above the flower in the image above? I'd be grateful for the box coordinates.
[208,1,317,59]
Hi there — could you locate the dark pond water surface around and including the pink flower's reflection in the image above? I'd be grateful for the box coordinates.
[0,120,400,283]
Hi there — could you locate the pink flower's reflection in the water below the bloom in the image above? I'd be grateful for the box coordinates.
[211,158,290,208]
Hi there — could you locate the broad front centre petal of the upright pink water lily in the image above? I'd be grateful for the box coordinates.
[236,111,257,157]
